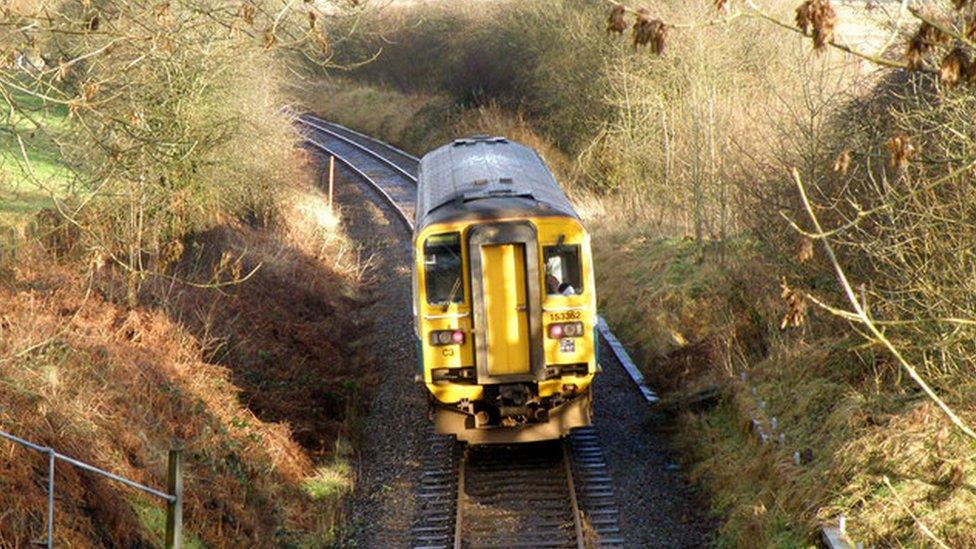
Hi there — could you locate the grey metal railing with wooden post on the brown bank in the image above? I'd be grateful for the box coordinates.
[0,431,183,549]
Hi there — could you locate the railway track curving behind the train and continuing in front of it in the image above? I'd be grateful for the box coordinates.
[298,115,624,548]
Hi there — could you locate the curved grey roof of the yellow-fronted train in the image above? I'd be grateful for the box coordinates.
[416,137,579,232]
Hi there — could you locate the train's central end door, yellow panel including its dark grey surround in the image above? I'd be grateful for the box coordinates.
[468,223,544,383]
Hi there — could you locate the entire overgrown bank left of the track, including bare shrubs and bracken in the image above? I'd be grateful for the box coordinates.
[0,0,384,547]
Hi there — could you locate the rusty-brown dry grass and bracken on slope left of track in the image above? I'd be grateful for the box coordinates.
[0,167,370,547]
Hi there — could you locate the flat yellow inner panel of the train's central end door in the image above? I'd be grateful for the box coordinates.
[481,244,532,376]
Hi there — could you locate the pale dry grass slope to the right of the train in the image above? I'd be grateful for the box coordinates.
[593,219,976,547]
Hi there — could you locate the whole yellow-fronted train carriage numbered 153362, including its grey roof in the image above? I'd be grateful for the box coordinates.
[413,137,598,444]
